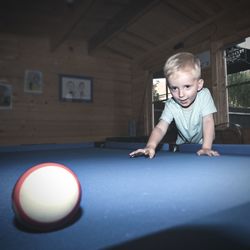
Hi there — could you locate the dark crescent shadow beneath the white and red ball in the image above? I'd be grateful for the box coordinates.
[13,207,84,234]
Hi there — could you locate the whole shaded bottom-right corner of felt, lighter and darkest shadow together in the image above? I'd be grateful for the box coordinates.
[106,203,250,250]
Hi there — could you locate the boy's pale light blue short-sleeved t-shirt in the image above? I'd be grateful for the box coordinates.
[160,88,217,145]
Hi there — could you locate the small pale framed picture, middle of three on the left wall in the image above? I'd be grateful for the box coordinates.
[24,70,43,94]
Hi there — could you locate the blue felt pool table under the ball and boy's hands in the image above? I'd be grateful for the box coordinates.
[0,142,250,250]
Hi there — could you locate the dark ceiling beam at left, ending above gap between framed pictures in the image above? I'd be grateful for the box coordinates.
[50,0,96,52]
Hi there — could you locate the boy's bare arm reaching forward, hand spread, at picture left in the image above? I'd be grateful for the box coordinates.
[129,120,169,158]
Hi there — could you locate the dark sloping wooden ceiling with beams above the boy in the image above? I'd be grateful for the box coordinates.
[0,0,250,60]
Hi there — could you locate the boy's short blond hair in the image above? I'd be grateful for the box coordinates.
[163,52,201,79]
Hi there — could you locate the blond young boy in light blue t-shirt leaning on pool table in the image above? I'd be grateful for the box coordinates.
[130,52,219,158]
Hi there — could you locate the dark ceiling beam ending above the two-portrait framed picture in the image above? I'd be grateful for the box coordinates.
[88,0,160,53]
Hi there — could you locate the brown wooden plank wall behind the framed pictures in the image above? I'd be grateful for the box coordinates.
[0,34,134,145]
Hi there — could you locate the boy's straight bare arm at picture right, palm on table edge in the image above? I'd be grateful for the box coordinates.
[197,114,219,156]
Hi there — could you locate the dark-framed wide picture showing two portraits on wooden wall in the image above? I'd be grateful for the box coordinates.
[60,75,93,102]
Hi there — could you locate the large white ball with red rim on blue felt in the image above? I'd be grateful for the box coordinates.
[12,163,81,229]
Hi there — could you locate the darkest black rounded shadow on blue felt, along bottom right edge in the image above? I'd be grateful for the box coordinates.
[107,225,249,250]
